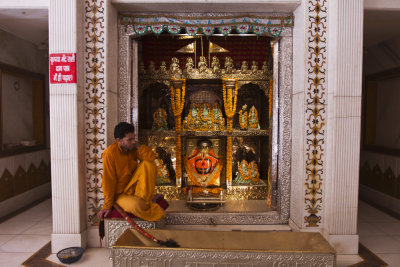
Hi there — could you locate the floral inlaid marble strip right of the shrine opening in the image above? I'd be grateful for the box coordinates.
[304,0,328,227]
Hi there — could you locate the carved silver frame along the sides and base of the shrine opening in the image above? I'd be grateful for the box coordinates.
[118,14,293,225]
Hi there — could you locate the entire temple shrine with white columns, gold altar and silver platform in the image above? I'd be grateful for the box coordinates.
[2,0,363,266]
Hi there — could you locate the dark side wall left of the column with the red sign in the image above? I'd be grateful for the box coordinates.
[0,27,51,218]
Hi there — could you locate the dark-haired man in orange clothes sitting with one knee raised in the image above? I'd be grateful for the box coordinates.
[97,122,165,221]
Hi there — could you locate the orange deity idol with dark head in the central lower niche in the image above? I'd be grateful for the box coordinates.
[184,139,222,187]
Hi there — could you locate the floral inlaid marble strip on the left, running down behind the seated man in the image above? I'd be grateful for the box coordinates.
[84,0,106,225]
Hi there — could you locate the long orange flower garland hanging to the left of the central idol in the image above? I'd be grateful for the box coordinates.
[170,78,186,185]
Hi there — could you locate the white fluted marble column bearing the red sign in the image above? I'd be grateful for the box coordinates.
[49,0,86,253]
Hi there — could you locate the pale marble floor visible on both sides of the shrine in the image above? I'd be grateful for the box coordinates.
[0,199,400,267]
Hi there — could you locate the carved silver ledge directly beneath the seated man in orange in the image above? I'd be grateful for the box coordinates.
[104,219,165,248]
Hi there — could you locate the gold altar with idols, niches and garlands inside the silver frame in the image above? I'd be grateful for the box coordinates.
[138,34,272,209]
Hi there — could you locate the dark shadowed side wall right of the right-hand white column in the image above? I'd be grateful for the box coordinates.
[360,36,400,216]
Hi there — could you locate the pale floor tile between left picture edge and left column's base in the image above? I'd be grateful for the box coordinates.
[0,235,50,254]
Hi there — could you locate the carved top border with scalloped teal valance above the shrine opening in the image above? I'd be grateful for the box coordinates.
[121,14,293,37]
